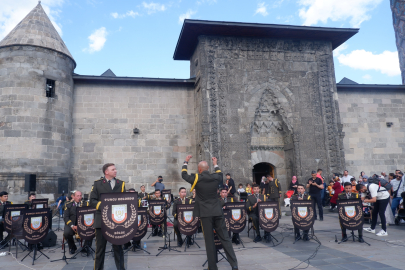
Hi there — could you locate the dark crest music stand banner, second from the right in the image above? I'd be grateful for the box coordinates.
[290,200,315,230]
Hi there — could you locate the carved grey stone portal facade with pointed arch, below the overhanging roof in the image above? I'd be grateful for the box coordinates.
[190,36,344,189]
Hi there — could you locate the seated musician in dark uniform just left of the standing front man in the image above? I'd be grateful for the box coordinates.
[63,190,92,254]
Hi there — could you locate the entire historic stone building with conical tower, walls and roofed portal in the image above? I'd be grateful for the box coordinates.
[0,4,405,201]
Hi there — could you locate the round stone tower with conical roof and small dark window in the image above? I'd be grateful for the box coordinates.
[0,3,76,200]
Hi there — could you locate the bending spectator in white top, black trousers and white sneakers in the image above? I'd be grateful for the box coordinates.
[356,179,390,236]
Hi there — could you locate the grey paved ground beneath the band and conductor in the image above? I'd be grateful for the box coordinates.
[0,206,405,270]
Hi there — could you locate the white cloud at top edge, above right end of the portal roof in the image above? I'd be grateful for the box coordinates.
[298,0,383,27]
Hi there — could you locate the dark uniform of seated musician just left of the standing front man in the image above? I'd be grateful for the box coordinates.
[63,201,91,254]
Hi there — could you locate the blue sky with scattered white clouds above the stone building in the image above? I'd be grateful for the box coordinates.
[0,0,401,84]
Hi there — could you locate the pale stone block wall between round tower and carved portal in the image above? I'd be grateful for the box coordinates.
[71,81,197,194]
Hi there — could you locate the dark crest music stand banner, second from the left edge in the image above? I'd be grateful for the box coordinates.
[23,209,50,244]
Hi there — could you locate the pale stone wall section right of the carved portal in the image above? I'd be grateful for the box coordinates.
[338,86,405,178]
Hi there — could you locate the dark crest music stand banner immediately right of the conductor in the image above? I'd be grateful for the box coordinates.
[224,202,246,233]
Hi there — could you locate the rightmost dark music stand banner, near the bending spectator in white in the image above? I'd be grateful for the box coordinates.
[337,199,364,230]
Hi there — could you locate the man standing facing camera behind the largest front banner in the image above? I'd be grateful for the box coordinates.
[90,163,126,270]
